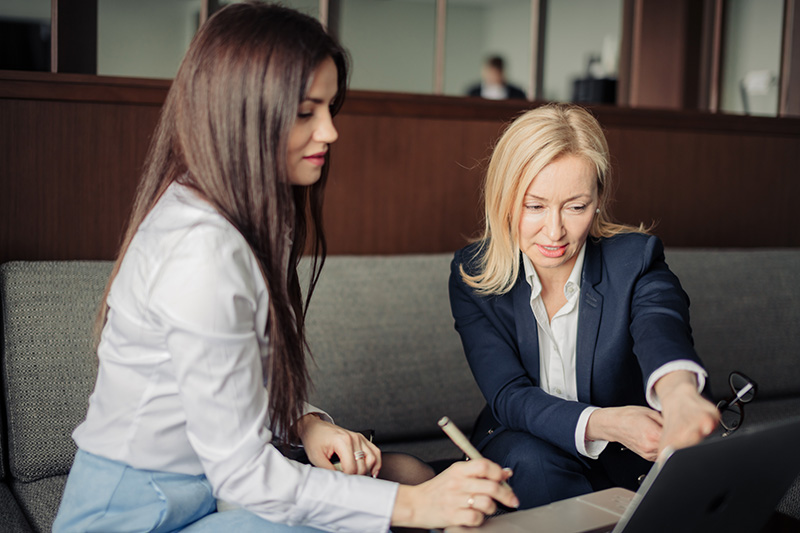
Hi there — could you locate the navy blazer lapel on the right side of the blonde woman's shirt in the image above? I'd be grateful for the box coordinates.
[575,238,603,403]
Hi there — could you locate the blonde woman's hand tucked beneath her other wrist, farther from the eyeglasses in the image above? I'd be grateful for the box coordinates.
[586,405,664,461]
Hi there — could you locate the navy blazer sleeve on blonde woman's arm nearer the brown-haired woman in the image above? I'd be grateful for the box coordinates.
[449,247,589,457]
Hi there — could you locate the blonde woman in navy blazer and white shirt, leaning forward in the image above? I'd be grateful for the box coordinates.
[450,105,719,508]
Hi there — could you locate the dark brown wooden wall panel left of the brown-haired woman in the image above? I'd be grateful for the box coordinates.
[0,99,160,261]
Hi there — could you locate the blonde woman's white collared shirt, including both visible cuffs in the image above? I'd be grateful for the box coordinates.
[522,243,706,459]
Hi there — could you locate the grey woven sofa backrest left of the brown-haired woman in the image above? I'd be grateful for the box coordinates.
[0,261,111,482]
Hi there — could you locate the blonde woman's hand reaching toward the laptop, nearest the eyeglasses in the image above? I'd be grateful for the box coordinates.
[655,370,720,454]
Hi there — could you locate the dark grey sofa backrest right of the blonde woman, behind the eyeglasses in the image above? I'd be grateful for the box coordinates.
[666,249,800,399]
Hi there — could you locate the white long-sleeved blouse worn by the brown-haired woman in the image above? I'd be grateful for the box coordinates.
[73,184,397,532]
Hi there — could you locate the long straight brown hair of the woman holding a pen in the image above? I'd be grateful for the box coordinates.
[97,2,347,439]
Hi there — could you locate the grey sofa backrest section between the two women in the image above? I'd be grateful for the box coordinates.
[304,254,484,442]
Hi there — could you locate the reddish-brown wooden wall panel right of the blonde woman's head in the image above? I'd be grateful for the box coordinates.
[608,128,800,247]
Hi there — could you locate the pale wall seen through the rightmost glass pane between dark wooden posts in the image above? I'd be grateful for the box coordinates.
[720,0,783,115]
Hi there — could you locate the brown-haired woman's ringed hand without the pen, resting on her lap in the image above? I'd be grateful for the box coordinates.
[298,413,381,477]
